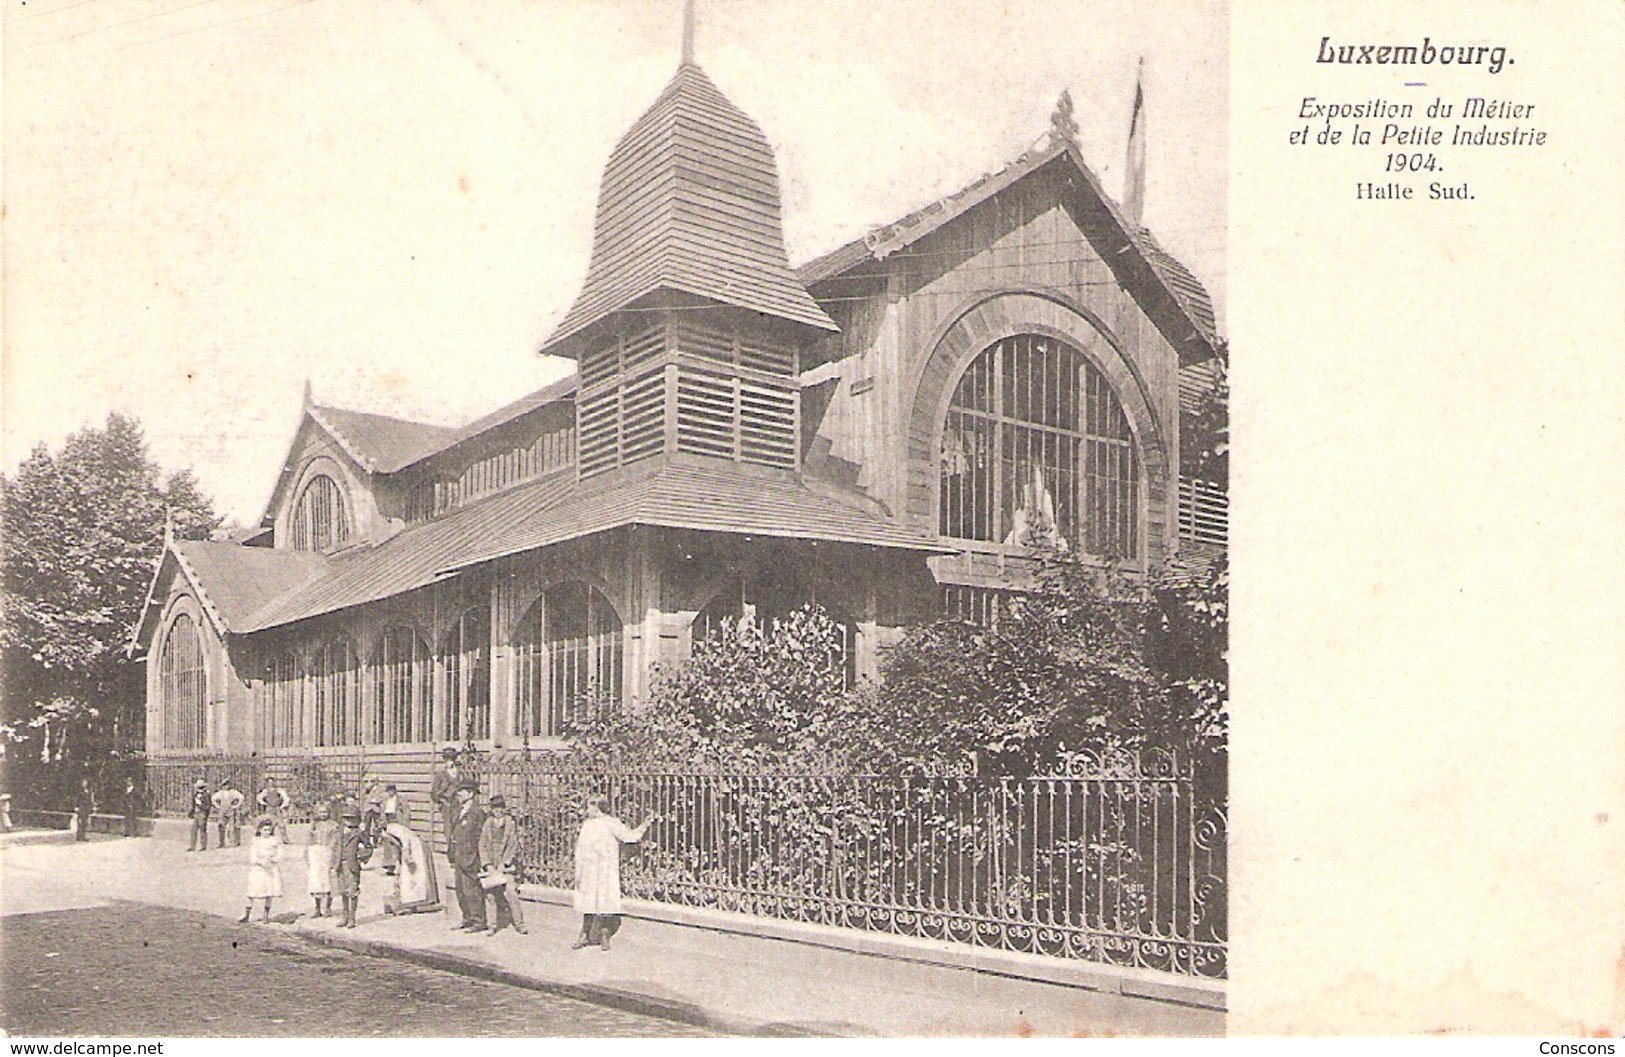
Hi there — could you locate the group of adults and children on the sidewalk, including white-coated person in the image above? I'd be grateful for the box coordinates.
[212,748,653,950]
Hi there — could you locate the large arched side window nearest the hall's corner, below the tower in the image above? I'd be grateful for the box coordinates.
[514,582,624,737]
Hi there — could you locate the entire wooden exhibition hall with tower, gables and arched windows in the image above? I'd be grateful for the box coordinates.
[135,62,1224,776]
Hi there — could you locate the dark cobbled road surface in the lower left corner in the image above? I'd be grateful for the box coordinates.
[0,903,712,1037]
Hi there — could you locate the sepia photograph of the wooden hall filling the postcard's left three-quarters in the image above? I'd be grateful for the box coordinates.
[0,0,1229,1037]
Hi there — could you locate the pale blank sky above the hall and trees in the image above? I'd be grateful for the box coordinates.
[0,0,1229,524]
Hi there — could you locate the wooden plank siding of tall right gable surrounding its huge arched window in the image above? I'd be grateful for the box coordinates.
[799,169,1178,558]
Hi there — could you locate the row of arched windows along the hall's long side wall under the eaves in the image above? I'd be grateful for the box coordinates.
[260,582,624,748]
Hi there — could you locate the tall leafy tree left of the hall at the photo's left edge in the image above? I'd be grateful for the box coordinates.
[0,413,219,797]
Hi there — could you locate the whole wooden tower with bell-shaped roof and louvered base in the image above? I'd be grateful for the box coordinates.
[541,62,837,478]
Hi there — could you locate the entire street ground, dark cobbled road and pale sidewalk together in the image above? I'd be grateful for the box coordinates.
[0,823,1224,1037]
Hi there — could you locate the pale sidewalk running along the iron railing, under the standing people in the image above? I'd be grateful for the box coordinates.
[0,826,1224,1036]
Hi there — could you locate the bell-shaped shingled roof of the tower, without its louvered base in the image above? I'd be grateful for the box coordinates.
[543,62,839,355]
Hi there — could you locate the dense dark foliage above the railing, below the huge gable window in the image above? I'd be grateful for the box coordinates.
[874,548,1229,774]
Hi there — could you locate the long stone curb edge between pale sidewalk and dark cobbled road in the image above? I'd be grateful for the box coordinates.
[289,925,834,1039]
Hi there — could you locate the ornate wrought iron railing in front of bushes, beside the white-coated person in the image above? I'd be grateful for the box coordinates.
[478,753,1227,977]
